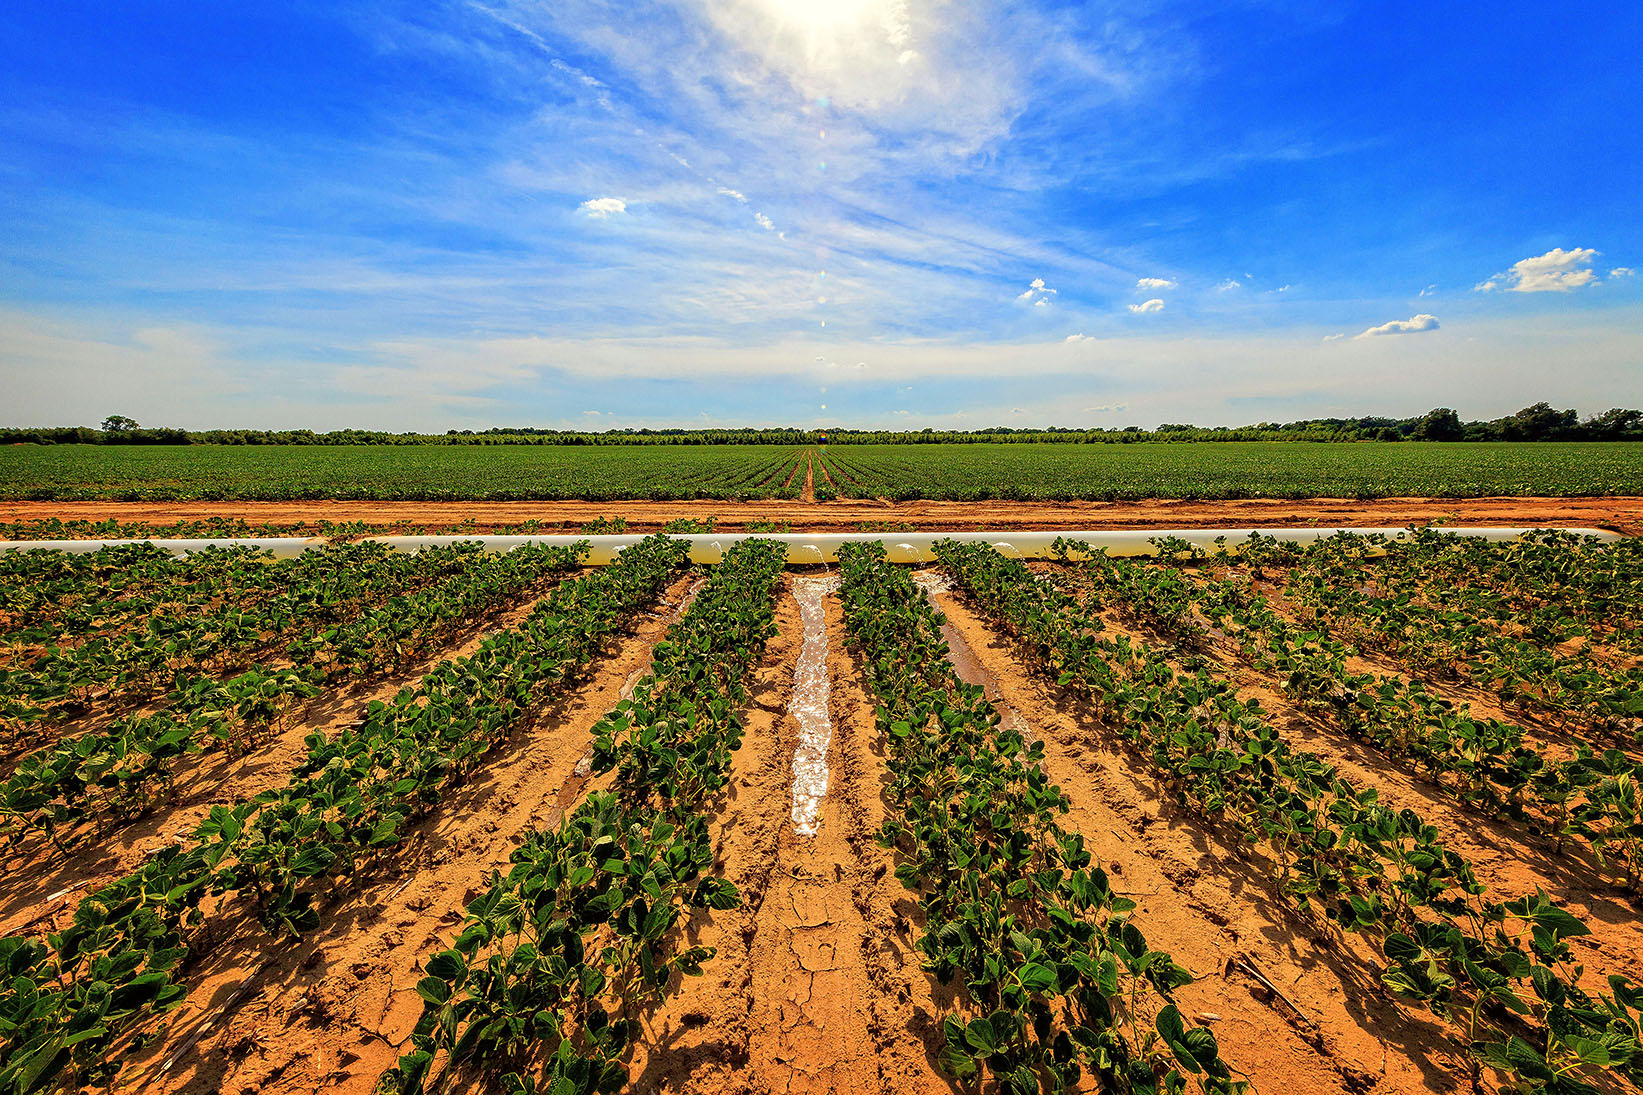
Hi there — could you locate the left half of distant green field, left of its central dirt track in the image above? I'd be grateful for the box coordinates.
[0,446,805,501]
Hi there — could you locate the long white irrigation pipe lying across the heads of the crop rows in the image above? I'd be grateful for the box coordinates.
[0,528,1623,566]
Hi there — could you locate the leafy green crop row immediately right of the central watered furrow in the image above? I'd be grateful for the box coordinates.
[840,543,1245,1095]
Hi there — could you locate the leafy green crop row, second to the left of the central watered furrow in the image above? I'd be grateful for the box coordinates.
[0,536,687,1092]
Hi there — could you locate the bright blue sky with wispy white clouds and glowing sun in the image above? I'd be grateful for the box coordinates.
[0,0,1643,429]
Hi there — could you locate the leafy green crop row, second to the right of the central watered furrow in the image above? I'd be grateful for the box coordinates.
[937,541,1643,1092]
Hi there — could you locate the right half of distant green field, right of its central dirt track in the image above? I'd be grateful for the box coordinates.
[817,441,1643,501]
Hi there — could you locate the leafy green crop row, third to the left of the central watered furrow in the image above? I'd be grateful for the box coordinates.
[0,544,585,848]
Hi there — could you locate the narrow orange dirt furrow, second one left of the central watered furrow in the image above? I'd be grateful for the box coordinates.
[0,578,604,934]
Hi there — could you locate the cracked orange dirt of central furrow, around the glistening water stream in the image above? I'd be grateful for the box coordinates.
[629,575,953,1095]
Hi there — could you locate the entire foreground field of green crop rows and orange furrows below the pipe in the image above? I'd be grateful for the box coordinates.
[0,529,1643,1095]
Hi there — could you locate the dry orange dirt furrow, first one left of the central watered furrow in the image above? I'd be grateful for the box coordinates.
[107,577,692,1095]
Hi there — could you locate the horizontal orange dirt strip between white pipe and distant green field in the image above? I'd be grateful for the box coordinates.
[0,493,1643,534]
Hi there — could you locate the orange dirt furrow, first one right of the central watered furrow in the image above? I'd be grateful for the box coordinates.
[935,594,1464,1095]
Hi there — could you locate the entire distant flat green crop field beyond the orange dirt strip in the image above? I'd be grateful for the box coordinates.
[0,441,1643,501]
